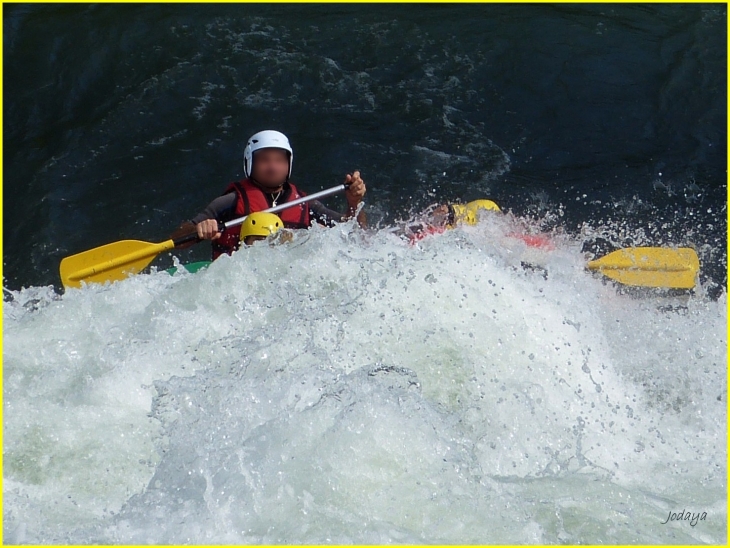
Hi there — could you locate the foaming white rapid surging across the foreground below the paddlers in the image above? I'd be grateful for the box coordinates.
[3,216,727,544]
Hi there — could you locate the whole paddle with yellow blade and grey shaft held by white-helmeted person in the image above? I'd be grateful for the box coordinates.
[60,184,348,287]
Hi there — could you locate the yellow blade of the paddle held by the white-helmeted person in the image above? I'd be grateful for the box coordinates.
[61,240,175,287]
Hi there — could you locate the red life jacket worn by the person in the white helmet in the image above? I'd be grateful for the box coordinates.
[212,179,309,261]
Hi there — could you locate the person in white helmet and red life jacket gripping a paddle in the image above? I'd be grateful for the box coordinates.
[171,130,366,259]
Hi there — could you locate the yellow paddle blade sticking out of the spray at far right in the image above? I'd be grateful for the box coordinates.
[586,247,700,289]
